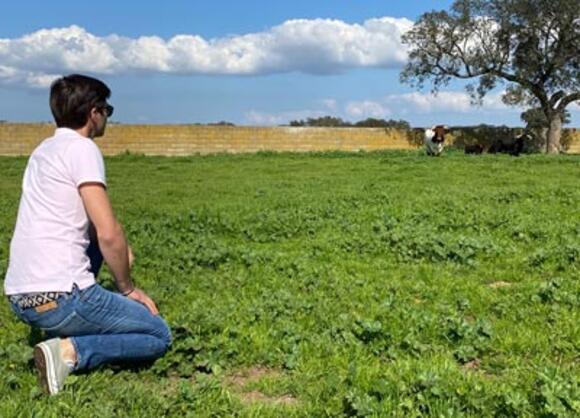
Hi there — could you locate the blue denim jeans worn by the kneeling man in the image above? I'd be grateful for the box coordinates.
[12,284,171,370]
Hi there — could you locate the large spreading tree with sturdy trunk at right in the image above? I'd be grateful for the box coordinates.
[401,0,580,153]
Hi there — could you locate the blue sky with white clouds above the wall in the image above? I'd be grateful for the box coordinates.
[0,0,580,127]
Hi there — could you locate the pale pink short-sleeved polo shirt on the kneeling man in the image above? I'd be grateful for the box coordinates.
[4,128,106,295]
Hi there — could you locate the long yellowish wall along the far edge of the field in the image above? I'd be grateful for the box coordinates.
[0,123,580,155]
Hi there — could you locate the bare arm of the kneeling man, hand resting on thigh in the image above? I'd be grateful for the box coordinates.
[79,183,158,314]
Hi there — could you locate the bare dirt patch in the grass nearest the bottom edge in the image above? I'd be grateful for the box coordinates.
[223,366,298,405]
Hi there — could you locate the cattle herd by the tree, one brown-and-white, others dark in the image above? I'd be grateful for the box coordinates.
[424,125,532,156]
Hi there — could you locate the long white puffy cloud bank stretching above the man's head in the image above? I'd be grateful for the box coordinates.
[0,17,413,85]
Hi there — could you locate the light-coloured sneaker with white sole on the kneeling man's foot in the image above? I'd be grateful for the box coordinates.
[34,338,70,395]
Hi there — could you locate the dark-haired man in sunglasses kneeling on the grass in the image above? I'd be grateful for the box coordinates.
[4,74,171,394]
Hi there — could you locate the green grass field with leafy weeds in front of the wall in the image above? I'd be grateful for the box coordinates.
[0,152,580,417]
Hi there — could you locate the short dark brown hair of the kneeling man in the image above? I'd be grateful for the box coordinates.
[50,74,111,129]
